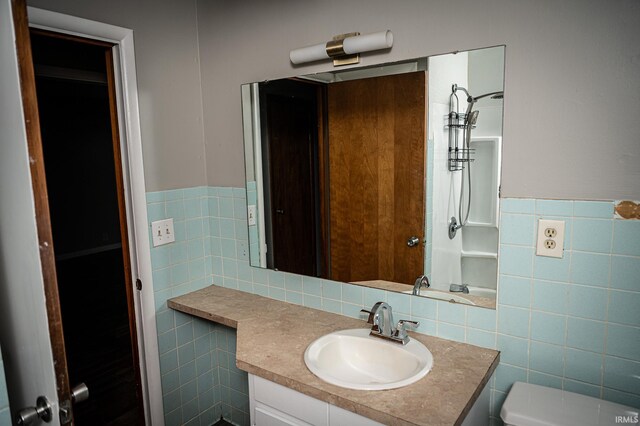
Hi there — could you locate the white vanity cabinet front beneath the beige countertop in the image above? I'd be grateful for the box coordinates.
[249,374,382,426]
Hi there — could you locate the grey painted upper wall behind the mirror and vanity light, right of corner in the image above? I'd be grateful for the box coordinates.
[198,0,640,200]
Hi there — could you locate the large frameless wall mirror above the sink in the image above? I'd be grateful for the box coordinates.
[242,46,505,307]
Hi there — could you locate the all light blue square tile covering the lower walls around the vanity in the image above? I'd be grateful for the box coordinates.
[147,187,640,425]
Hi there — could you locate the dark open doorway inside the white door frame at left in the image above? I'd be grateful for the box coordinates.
[31,30,144,425]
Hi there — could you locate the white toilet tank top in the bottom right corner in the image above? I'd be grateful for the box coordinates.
[500,382,640,426]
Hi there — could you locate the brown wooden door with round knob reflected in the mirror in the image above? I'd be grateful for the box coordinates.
[327,72,427,284]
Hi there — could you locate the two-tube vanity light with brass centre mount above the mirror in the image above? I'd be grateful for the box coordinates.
[289,30,393,67]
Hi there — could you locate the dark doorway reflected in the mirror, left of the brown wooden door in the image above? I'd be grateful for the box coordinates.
[261,82,319,276]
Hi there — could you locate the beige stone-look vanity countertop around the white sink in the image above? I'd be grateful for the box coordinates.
[168,286,499,425]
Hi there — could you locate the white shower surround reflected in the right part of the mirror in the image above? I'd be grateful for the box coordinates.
[428,50,503,291]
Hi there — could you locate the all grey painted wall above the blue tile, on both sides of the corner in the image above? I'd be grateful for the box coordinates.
[28,0,640,200]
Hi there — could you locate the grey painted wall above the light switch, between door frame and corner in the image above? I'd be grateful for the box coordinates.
[28,0,205,191]
